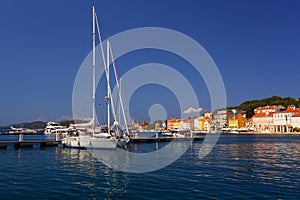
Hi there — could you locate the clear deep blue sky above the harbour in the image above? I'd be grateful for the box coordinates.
[0,0,300,125]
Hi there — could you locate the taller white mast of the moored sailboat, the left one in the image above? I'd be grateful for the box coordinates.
[92,5,96,135]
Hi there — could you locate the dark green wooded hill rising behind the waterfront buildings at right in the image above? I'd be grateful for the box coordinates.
[228,96,300,118]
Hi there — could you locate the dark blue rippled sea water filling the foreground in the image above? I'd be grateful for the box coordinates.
[0,135,300,199]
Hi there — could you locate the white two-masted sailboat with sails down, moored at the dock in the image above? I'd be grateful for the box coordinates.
[63,6,130,149]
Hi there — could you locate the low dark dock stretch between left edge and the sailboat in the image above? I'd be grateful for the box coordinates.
[0,140,61,149]
